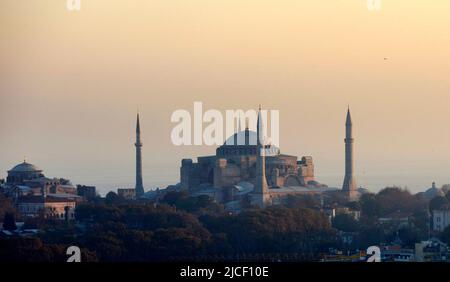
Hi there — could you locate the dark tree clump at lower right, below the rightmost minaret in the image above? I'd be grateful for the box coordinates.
[332,187,431,249]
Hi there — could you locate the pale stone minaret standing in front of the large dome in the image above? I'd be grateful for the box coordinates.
[252,106,270,208]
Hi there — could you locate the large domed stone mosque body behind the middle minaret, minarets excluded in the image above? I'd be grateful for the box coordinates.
[180,124,323,201]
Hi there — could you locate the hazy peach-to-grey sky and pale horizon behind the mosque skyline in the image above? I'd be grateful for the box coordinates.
[0,0,450,195]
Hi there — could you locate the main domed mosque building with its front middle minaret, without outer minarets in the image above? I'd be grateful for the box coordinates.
[180,106,356,207]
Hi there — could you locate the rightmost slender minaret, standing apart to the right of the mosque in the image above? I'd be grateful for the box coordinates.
[342,108,358,201]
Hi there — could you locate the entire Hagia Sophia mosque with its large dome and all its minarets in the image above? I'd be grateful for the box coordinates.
[134,107,358,208]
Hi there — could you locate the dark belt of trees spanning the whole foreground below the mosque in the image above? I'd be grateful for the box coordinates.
[0,187,450,261]
